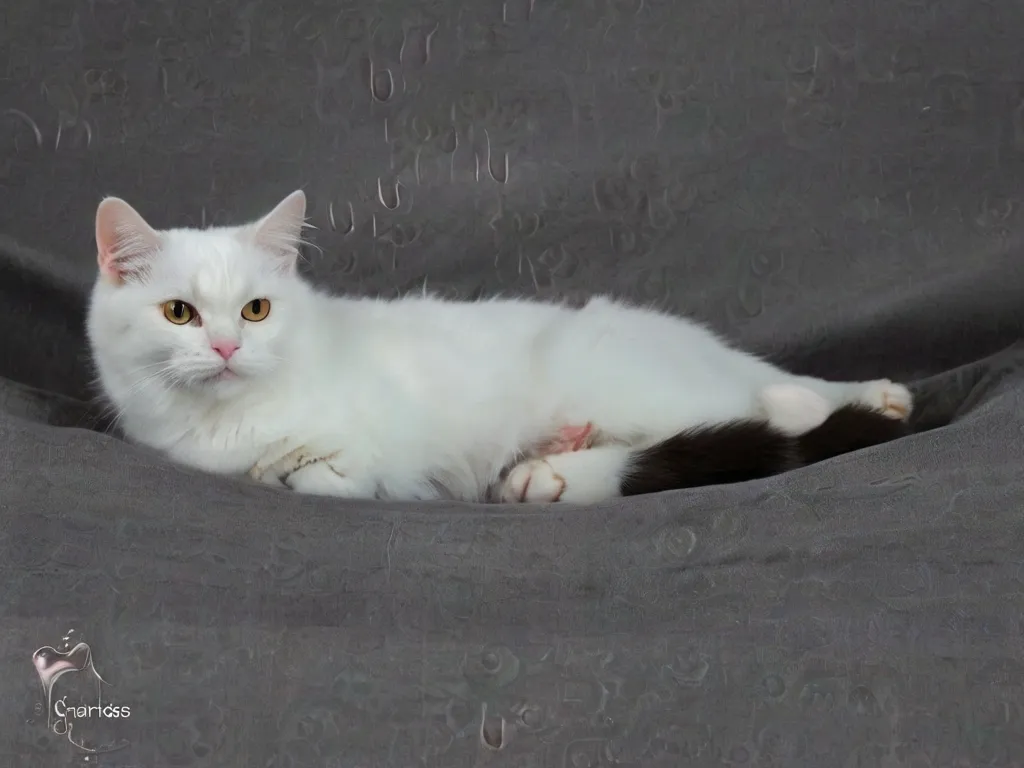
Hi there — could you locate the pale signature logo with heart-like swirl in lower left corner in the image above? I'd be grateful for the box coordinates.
[32,630,131,755]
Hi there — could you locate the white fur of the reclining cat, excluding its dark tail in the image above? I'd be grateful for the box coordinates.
[88,191,910,502]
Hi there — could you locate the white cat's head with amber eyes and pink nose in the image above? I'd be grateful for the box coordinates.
[89,191,309,397]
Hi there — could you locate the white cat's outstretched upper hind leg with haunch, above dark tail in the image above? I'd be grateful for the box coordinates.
[534,299,912,455]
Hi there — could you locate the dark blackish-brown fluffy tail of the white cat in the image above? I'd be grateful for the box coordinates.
[620,406,910,496]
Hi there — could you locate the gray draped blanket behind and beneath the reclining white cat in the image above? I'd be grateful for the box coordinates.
[0,0,1024,768]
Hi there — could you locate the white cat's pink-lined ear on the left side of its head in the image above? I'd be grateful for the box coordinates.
[96,198,161,283]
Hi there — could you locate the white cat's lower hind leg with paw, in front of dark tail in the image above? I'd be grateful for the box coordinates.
[500,445,631,504]
